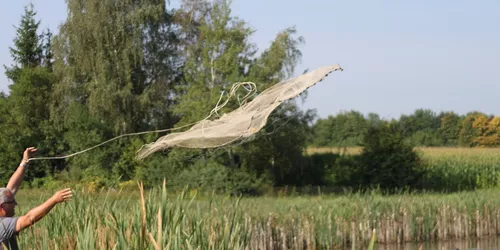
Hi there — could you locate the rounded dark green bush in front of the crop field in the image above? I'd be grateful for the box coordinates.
[308,124,423,191]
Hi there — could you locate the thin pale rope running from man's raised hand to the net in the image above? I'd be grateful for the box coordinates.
[27,82,257,162]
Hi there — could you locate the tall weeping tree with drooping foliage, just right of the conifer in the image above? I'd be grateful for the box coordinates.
[51,0,178,180]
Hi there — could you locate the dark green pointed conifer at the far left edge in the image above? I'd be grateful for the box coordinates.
[0,5,57,183]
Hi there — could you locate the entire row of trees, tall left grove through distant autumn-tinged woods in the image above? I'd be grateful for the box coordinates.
[0,0,499,194]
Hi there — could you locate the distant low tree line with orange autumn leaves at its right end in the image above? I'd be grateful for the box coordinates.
[309,109,500,147]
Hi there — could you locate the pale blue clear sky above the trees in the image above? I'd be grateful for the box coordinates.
[0,0,500,119]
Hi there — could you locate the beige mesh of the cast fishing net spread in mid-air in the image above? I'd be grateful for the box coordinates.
[137,64,342,159]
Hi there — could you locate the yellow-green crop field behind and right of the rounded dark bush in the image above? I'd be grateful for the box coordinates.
[307,147,500,192]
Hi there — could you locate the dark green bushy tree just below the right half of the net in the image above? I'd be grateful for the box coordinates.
[234,105,314,186]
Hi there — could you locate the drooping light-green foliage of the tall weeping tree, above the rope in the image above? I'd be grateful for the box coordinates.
[53,0,175,134]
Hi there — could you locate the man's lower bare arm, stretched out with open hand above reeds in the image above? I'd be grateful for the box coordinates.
[16,188,73,232]
